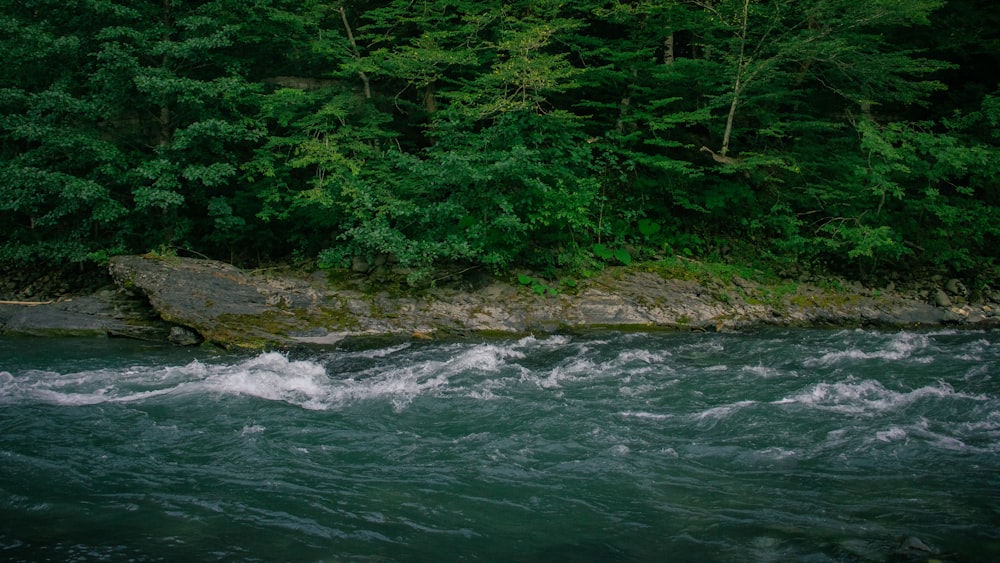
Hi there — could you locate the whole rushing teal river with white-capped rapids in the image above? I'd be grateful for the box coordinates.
[0,330,1000,561]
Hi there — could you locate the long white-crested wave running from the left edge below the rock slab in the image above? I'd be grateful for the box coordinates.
[0,336,670,411]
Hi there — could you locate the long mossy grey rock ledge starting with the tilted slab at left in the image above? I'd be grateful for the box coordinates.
[103,256,997,348]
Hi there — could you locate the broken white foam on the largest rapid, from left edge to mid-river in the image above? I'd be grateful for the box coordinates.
[0,337,548,410]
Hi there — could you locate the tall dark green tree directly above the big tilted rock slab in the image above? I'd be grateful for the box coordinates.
[91,0,263,258]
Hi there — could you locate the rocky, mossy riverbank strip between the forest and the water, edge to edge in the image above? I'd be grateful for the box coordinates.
[0,256,1000,348]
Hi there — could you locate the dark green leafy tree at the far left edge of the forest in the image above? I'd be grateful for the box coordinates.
[0,2,127,263]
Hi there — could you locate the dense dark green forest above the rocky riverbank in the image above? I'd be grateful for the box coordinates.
[0,0,1000,279]
